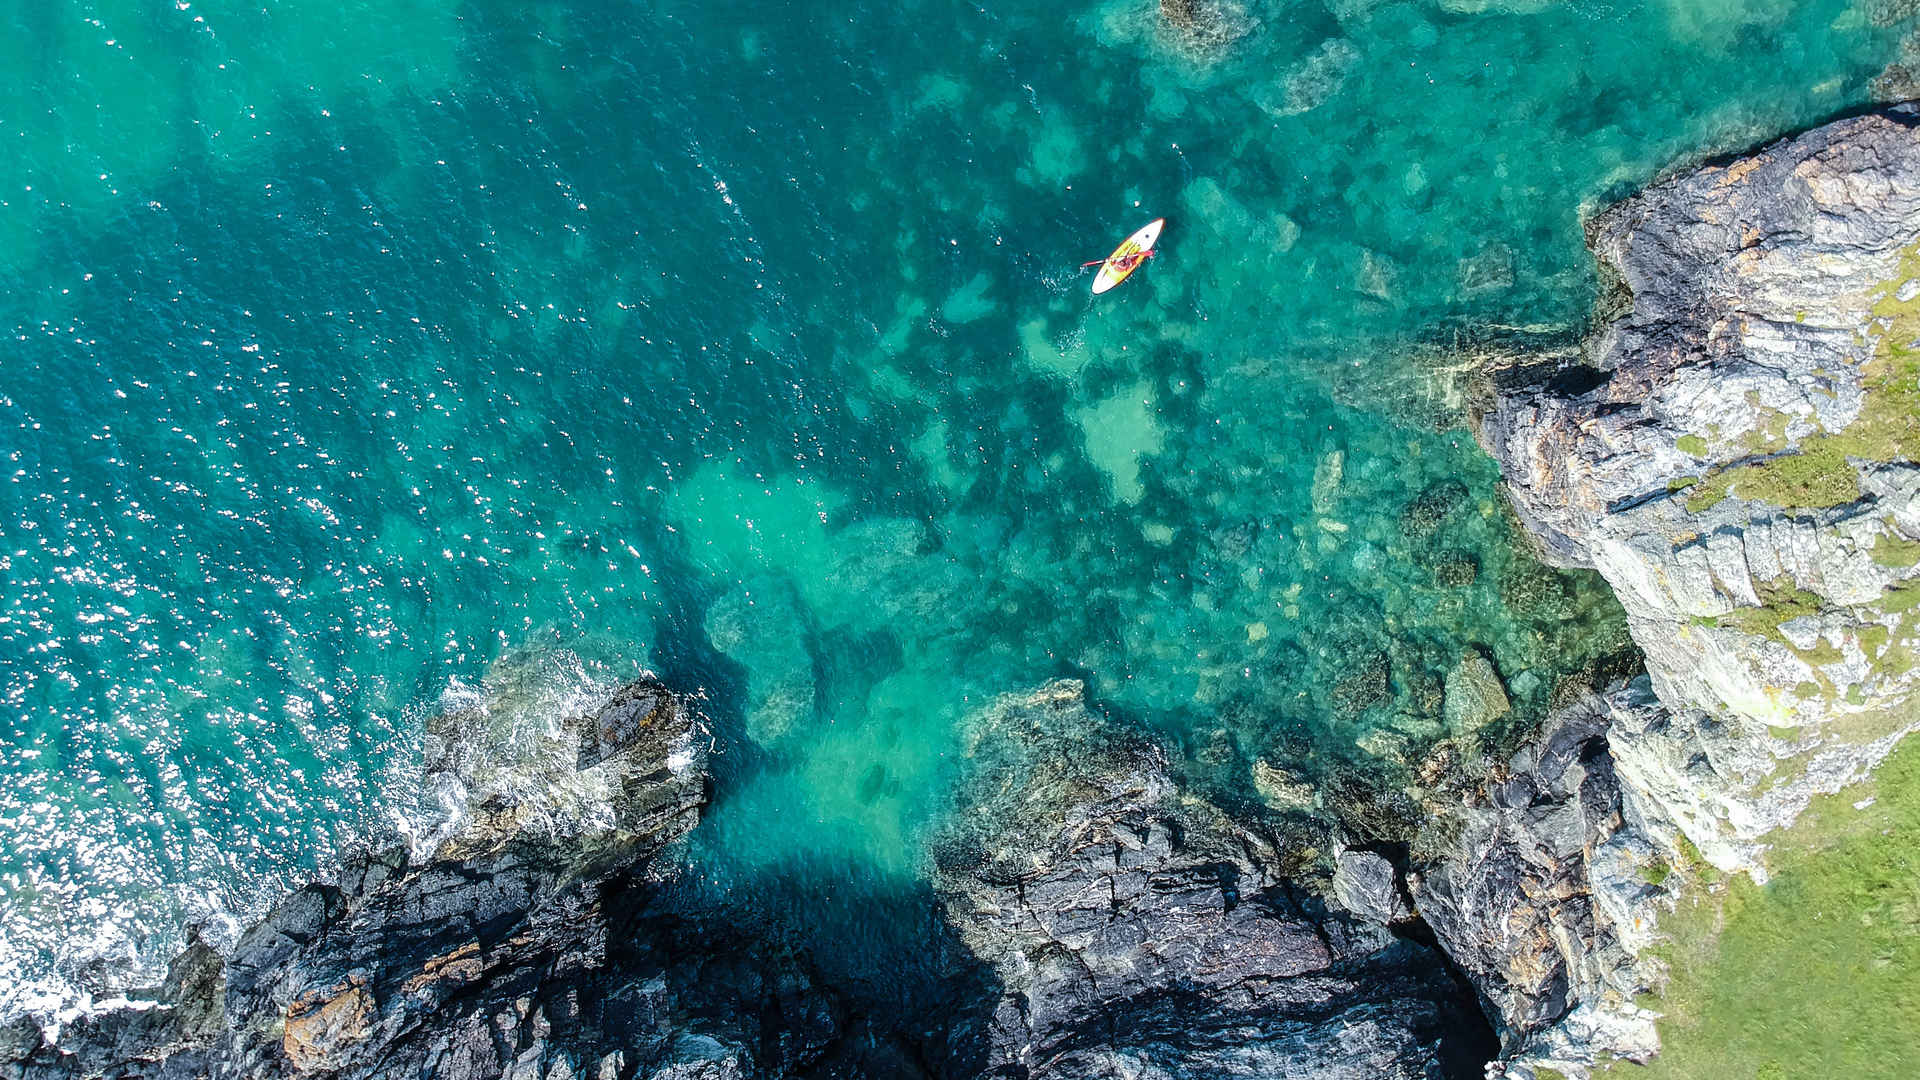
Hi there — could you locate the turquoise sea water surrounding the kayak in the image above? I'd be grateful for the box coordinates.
[0,0,1901,980]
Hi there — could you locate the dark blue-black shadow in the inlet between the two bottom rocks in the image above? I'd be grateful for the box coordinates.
[607,859,1000,1078]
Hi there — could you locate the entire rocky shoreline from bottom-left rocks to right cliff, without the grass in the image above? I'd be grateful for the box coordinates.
[11,105,1920,1080]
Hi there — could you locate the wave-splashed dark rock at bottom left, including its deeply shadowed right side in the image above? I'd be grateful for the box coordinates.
[0,680,985,1080]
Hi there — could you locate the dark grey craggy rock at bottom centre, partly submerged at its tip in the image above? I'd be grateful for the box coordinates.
[935,682,1492,1080]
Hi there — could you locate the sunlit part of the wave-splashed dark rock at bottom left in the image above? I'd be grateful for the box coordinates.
[0,680,725,1078]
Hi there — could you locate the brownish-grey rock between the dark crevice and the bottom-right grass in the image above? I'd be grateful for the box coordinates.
[1411,676,1667,1067]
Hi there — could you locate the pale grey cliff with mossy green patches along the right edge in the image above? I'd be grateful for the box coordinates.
[1480,106,1920,871]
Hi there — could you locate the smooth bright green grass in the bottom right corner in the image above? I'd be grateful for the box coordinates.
[1613,726,1920,1080]
